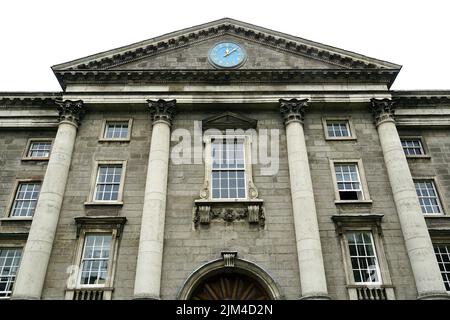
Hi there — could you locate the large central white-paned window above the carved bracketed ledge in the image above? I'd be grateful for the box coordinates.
[211,138,246,199]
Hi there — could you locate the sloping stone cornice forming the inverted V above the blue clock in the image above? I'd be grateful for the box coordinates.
[53,19,400,70]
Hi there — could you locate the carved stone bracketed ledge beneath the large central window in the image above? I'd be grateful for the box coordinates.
[192,199,266,227]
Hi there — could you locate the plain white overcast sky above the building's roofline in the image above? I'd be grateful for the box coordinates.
[0,0,450,91]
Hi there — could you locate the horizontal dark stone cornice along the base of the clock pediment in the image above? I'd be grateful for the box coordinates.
[55,69,399,88]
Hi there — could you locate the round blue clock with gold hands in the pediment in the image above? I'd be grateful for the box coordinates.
[208,42,247,68]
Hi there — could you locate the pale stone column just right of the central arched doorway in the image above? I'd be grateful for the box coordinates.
[280,99,329,299]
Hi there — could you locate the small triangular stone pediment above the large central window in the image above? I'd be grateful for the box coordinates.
[202,112,257,130]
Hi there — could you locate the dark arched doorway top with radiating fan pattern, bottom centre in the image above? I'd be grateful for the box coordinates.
[190,272,272,300]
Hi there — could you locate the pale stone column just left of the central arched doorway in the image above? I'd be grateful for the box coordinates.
[134,99,176,299]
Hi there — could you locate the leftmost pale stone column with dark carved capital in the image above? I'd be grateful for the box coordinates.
[12,100,84,299]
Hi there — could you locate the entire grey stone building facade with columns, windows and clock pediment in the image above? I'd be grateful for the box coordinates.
[0,18,450,300]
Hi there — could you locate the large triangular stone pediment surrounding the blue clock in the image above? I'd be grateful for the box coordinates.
[52,18,400,73]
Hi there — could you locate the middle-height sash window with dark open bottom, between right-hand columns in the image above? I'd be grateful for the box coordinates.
[334,163,363,200]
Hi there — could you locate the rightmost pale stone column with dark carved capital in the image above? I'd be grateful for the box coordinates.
[371,99,448,299]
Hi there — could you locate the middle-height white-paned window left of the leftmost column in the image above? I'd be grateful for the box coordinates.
[11,182,41,217]
